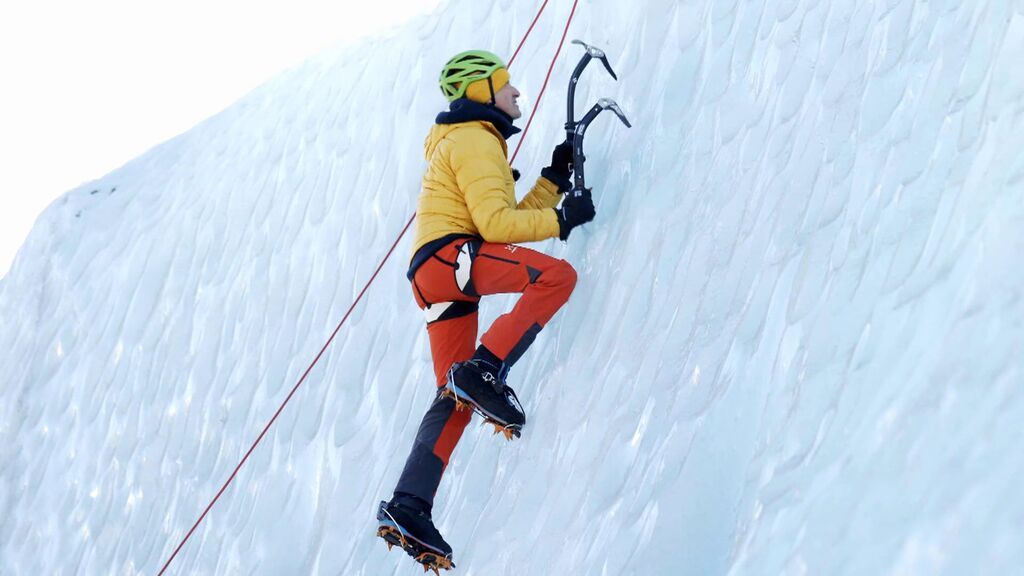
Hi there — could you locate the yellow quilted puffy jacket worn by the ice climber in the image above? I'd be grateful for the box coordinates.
[413,120,561,254]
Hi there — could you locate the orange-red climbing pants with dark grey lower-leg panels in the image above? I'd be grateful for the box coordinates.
[395,238,577,503]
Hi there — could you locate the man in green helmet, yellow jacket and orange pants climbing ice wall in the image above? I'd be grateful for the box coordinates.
[377,50,594,571]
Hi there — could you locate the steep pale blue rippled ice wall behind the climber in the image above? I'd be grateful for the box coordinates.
[0,0,1024,575]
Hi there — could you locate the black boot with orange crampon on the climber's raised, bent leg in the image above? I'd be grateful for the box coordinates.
[442,346,526,440]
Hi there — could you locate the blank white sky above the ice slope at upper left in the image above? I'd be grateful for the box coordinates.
[0,0,441,277]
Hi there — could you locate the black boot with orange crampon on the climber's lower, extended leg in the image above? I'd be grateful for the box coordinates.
[377,494,455,574]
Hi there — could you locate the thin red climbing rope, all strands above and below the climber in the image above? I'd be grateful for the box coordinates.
[158,0,579,576]
